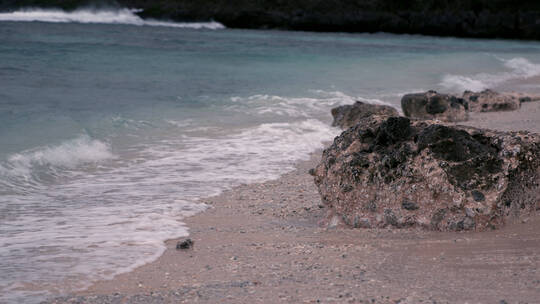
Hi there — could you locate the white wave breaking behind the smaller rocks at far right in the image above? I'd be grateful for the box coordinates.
[440,57,540,92]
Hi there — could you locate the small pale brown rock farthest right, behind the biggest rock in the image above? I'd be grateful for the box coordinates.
[463,90,521,112]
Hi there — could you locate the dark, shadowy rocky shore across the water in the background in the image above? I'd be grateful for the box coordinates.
[5,0,540,39]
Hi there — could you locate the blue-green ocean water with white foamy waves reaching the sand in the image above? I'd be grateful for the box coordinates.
[0,9,540,303]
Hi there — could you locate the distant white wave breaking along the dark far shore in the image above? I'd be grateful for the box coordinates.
[0,8,225,30]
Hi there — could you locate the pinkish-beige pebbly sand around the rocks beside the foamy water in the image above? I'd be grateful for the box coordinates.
[47,102,540,303]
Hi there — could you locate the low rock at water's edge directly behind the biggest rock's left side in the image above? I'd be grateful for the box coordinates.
[332,101,399,129]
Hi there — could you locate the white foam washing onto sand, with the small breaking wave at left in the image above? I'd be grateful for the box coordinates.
[0,101,339,302]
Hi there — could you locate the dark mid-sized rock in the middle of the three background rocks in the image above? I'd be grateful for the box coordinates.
[401,91,468,121]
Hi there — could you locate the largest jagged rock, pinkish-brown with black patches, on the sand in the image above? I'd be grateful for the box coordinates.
[314,117,540,231]
